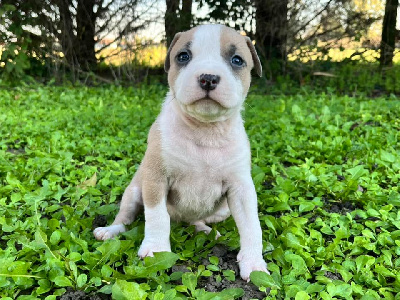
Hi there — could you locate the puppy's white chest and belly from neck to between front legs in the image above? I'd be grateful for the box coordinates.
[160,99,250,222]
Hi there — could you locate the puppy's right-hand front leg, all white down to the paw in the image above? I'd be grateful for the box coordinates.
[228,176,268,281]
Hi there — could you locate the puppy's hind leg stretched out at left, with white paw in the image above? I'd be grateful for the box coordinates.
[93,169,143,240]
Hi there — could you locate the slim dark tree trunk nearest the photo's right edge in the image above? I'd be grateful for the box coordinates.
[379,0,399,66]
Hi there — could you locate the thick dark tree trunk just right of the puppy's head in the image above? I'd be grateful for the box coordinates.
[255,0,288,72]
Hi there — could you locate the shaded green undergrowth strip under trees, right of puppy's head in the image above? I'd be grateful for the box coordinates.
[255,60,400,98]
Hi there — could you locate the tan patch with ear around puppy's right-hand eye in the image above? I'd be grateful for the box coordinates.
[220,27,262,91]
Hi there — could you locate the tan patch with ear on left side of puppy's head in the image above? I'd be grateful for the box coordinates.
[164,28,196,88]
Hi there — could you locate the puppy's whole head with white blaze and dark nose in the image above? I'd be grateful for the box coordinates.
[165,25,261,122]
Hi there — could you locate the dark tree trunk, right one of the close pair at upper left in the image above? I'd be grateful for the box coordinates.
[75,0,97,70]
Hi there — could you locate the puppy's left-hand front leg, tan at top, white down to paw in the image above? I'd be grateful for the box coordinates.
[138,181,171,258]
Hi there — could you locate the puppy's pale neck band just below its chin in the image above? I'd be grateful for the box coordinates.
[163,95,243,148]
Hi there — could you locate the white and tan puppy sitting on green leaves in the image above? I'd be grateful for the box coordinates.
[94,25,268,280]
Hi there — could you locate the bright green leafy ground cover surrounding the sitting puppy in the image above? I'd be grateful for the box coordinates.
[0,85,400,300]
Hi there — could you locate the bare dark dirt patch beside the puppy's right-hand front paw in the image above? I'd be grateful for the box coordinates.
[199,245,267,300]
